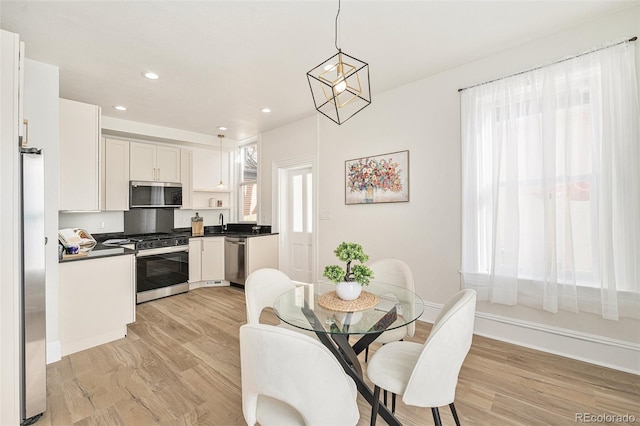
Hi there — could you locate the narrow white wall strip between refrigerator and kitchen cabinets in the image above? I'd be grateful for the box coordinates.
[24,59,60,362]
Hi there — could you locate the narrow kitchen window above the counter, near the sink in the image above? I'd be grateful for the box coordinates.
[238,142,258,222]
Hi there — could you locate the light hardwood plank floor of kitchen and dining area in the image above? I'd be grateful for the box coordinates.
[36,287,640,426]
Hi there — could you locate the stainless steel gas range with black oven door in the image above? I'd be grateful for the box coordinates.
[128,234,189,303]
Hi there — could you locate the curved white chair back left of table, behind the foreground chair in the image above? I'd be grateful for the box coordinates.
[244,268,296,324]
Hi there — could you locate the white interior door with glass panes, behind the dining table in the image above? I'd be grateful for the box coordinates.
[280,166,313,283]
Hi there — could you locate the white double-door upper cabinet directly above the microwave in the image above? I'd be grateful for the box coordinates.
[129,142,180,182]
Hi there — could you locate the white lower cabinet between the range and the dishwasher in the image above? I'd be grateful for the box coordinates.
[189,237,224,283]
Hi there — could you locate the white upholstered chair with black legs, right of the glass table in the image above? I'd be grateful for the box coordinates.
[367,290,476,426]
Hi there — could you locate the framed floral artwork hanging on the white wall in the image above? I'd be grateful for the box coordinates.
[344,151,409,204]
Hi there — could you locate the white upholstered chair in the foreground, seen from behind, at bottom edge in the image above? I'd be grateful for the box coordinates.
[240,323,360,426]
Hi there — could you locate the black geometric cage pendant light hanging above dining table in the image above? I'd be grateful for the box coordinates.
[307,0,371,124]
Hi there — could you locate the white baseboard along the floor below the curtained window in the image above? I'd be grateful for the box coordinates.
[420,302,640,375]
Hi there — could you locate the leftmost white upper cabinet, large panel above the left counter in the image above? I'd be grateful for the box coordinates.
[59,99,100,211]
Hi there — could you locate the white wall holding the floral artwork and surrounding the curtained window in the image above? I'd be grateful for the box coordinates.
[261,6,640,371]
